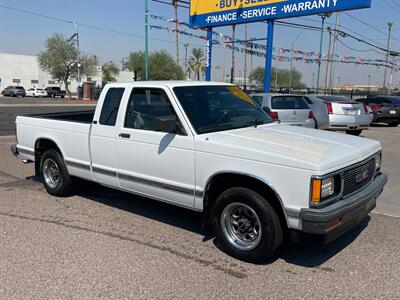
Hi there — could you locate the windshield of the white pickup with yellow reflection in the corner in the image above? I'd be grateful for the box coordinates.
[174,85,273,134]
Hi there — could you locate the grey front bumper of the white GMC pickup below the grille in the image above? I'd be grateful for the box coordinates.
[300,173,388,243]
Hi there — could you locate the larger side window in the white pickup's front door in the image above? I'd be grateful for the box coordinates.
[124,88,177,132]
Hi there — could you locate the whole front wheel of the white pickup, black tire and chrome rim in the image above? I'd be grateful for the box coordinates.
[212,187,283,263]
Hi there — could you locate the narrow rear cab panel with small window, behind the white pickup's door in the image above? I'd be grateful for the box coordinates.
[89,87,125,187]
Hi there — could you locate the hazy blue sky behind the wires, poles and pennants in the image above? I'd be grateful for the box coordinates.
[0,0,400,85]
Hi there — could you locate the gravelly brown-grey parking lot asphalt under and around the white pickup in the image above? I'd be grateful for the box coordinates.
[0,104,400,299]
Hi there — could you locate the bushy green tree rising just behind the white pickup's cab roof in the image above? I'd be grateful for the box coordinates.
[124,50,185,80]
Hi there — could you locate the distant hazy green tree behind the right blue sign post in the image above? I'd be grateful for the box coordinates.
[250,67,306,89]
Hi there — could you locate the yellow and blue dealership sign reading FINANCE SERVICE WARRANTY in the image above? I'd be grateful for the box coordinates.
[190,0,371,27]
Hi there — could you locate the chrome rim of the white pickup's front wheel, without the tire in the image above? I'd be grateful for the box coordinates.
[221,202,262,251]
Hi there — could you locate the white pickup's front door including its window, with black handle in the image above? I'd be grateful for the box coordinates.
[116,87,195,207]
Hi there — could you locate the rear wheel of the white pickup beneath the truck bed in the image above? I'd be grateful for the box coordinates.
[40,149,72,196]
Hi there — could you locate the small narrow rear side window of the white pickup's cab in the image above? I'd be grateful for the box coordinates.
[99,88,125,126]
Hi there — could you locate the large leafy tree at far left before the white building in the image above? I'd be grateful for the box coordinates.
[38,33,97,97]
